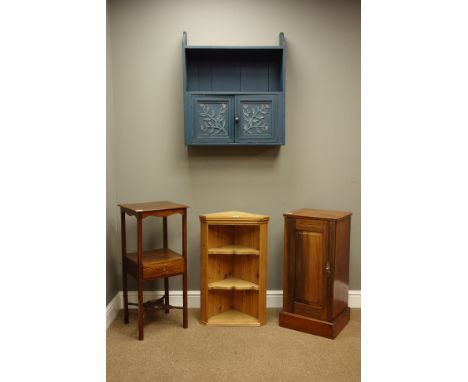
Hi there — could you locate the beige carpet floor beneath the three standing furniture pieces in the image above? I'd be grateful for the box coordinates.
[106,309,361,382]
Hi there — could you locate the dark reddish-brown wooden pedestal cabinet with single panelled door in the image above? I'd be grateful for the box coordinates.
[279,208,351,338]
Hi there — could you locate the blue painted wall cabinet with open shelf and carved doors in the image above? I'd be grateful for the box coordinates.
[182,32,285,146]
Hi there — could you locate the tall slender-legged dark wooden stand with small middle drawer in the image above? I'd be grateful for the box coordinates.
[119,201,188,340]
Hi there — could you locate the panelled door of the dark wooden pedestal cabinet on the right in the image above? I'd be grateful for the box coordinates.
[289,219,330,320]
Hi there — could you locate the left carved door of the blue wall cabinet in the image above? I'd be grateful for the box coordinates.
[191,95,234,145]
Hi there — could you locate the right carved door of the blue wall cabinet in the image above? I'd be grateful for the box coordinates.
[234,95,278,143]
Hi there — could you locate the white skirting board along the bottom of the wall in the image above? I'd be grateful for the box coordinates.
[106,290,361,328]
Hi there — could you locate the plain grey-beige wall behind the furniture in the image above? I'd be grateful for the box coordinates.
[107,0,361,301]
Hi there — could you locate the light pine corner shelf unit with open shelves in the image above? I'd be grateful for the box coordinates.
[200,211,269,326]
